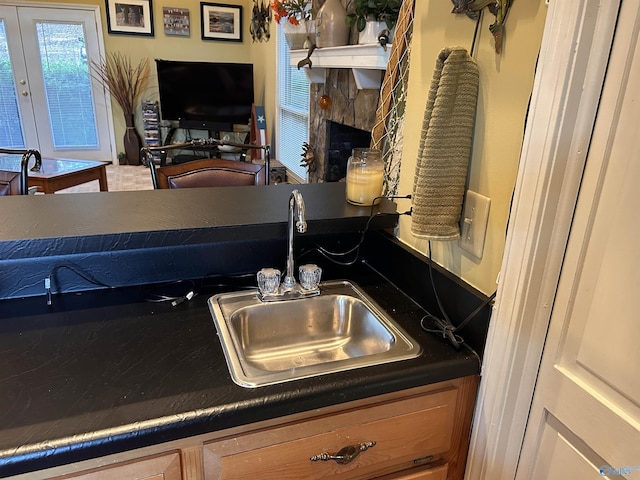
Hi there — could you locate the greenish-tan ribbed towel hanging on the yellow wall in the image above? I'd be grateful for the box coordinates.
[411,47,479,240]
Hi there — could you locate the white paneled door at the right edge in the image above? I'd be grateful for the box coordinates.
[516,0,640,480]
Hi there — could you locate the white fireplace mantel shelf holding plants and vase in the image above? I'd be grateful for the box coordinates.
[290,43,391,90]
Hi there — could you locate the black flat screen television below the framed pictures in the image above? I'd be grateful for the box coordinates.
[156,59,253,131]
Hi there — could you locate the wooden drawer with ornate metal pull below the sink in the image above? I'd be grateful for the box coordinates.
[204,388,457,480]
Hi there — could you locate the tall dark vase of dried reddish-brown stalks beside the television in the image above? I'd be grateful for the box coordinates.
[91,52,149,165]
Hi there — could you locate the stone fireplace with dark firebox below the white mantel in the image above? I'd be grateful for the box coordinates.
[309,69,380,183]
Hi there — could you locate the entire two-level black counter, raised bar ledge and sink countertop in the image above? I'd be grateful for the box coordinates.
[0,183,489,477]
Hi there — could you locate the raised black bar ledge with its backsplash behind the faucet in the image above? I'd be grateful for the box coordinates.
[0,183,397,299]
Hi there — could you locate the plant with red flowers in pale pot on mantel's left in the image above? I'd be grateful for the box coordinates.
[271,0,314,50]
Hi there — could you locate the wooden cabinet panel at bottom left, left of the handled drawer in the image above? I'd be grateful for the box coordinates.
[54,453,182,480]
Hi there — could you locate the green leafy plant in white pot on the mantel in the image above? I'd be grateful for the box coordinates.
[345,0,402,44]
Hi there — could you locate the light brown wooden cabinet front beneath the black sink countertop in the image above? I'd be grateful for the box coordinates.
[25,376,478,480]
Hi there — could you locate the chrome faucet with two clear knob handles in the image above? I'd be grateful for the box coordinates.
[258,190,322,302]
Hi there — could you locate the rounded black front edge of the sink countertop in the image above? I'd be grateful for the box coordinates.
[0,355,479,478]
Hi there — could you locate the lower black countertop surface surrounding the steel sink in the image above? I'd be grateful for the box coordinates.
[0,264,479,476]
